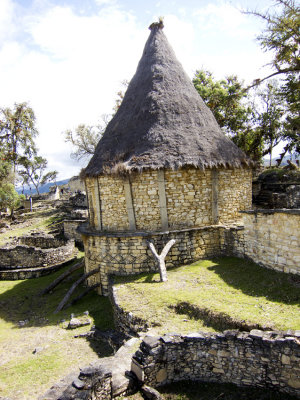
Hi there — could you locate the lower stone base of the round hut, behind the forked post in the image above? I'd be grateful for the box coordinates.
[79,225,227,295]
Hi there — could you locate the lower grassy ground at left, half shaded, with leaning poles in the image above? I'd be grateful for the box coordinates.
[0,254,113,400]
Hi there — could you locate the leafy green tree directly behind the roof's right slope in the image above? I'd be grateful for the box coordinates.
[193,70,286,161]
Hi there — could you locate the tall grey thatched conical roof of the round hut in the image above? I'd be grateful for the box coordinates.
[85,24,251,176]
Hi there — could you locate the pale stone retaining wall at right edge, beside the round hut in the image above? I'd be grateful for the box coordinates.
[241,209,300,275]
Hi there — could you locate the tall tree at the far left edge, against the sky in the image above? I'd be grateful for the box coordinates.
[0,103,38,173]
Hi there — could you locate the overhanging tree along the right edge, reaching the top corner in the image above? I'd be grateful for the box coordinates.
[244,0,300,162]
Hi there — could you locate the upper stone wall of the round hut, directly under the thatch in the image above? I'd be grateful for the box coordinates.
[86,168,252,231]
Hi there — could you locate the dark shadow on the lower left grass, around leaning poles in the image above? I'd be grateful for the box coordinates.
[0,259,114,351]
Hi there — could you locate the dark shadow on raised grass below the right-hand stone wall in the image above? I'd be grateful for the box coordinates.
[208,257,300,305]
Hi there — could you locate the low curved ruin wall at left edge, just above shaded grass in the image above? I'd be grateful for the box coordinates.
[0,236,75,270]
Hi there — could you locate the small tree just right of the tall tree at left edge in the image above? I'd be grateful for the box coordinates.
[19,156,57,194]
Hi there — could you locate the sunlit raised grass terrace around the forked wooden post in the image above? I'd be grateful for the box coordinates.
[116,257,300,334]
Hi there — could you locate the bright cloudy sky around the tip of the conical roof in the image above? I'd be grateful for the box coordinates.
[0,0,273,180]
